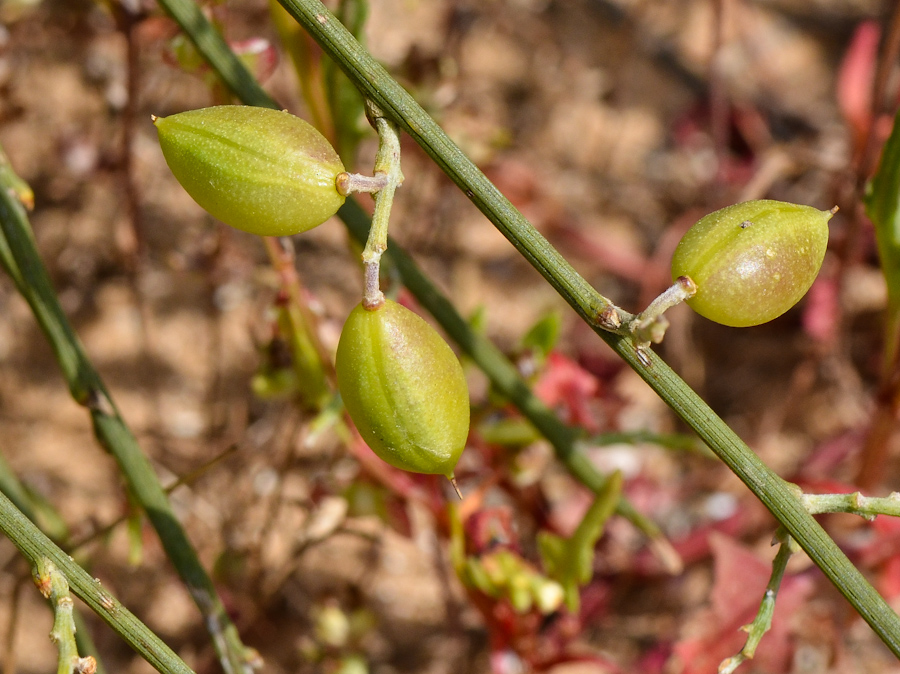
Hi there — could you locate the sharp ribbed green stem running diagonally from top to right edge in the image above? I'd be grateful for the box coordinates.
[272,0,900,656]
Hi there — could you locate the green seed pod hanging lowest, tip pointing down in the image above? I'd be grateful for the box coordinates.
[335,300,469,477]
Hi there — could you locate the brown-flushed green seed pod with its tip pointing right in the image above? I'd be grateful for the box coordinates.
[672,200,833,327]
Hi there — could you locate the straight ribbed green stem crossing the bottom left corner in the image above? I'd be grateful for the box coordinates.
[0,494,193,674]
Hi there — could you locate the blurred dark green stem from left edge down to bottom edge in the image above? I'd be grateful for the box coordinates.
[0,154,258,674]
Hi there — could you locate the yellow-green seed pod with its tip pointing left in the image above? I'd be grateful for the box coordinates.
[154,105,344,236]
